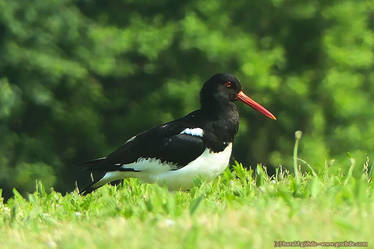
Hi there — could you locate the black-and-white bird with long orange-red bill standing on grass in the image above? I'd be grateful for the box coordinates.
[80,73,276,195]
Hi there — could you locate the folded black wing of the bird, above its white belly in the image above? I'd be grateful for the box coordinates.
[87,113,206,171]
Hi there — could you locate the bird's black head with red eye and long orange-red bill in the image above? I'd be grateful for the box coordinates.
[200,73,276,119]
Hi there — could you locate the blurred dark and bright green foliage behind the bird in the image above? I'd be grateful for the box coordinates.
[0,0,374,197]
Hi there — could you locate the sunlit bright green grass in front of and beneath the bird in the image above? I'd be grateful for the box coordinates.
[0,135,374,249]
